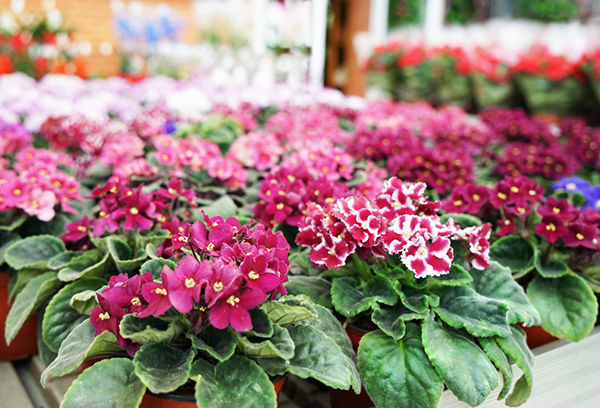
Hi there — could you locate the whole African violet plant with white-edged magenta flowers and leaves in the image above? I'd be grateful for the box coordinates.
[287,178,540,407]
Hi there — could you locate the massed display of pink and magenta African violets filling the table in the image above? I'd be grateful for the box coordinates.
[0,87,600,407]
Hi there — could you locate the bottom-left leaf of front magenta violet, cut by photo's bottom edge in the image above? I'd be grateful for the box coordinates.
[60,358,146,408]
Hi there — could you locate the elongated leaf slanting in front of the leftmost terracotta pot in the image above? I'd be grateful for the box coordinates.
[4,272,61,344]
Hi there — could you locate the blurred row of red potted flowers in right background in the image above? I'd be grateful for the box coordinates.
[364,41,600,116]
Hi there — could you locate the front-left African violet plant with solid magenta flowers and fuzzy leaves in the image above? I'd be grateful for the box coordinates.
[42,210,361,408]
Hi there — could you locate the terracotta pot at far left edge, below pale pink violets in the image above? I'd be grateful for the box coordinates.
[0,272,38,361]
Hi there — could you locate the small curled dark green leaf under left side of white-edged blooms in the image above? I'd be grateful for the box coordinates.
[331,276,398,317]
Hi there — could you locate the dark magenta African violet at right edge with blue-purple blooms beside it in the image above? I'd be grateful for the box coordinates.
[444,176,600,341]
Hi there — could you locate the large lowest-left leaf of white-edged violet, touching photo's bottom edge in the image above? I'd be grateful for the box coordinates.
[358,323,444,408]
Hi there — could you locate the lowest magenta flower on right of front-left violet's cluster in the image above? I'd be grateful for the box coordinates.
[208,287,266,332]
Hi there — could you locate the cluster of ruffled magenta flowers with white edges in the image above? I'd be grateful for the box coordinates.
[296,177,491,278]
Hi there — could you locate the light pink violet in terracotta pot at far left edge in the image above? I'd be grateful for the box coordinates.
[0,138,80,360]
